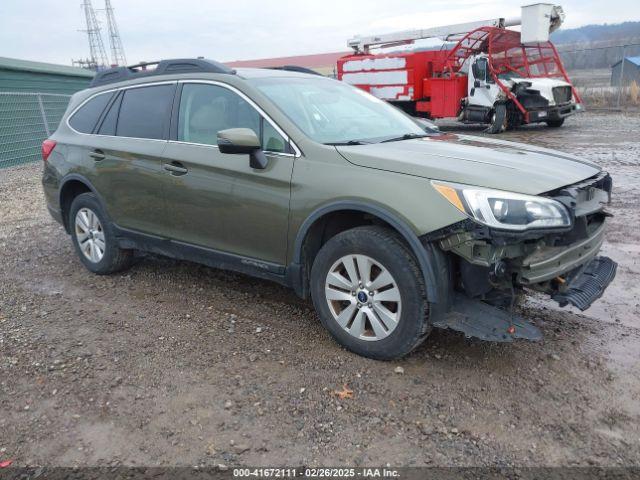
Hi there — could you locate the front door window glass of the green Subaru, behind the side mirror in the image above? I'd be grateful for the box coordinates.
[178,83,287,152]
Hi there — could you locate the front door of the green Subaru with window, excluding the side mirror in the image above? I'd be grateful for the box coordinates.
[163,82,295,265]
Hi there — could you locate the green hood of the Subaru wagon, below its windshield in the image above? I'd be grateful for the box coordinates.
[337,133,601,195]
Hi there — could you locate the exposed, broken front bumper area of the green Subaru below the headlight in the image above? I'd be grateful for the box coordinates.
[425,172,617,341]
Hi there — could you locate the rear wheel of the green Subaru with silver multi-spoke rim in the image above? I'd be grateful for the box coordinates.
[69,193,133,275]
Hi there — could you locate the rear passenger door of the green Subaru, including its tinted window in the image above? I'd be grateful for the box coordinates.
[88,82,176,235]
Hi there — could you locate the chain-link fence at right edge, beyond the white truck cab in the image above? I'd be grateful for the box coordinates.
[558,43,640,109]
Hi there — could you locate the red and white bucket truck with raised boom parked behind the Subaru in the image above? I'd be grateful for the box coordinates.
[338,4,582,133]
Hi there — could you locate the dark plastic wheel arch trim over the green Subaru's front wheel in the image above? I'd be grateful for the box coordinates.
[288,201,441,303]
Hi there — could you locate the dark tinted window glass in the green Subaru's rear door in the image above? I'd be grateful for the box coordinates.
[117,85,175,139]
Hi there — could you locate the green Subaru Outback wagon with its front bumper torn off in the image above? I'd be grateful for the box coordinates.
[42,59,616,359]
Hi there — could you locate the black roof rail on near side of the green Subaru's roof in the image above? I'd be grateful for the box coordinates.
[89,58,236,87]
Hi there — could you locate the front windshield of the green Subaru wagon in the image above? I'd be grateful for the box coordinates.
[250,77,425,144]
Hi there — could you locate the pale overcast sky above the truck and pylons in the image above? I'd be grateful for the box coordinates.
[0,0,640,64]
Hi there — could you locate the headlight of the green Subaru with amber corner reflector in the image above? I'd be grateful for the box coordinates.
[432,182,571,230]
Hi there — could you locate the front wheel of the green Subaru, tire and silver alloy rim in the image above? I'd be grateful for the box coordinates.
[311,226,431,360]
